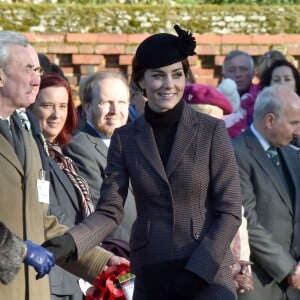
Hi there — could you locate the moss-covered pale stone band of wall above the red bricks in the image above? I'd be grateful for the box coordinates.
[0,0,300,34]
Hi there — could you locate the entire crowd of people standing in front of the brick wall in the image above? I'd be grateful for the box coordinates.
[0,25,300,300]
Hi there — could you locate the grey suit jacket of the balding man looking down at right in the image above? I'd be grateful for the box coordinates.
[233,129,300,300]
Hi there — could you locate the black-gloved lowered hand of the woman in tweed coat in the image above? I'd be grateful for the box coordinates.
[166,270,207,300]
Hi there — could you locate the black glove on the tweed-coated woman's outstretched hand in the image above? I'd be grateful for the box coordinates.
[42,233,76,262]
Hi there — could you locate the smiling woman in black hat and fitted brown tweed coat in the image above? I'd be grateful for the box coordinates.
[44,26,241,300]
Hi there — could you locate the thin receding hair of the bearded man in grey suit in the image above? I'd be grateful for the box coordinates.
[82,71,129,105]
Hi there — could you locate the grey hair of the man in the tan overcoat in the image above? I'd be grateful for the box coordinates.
[0,31,29,67]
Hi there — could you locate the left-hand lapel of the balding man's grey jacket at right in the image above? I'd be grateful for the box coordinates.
[246,131,293,212]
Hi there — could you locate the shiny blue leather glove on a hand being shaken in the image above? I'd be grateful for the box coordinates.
[24,240,55,279]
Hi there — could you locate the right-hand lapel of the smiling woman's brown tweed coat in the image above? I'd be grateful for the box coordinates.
[166,106,196,178]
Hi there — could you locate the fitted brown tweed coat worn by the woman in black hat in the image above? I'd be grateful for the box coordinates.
[70,105,241,300]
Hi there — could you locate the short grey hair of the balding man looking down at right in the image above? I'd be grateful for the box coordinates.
[253,84,284,121]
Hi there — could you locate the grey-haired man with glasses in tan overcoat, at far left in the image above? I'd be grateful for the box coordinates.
[0,31,127,300]
